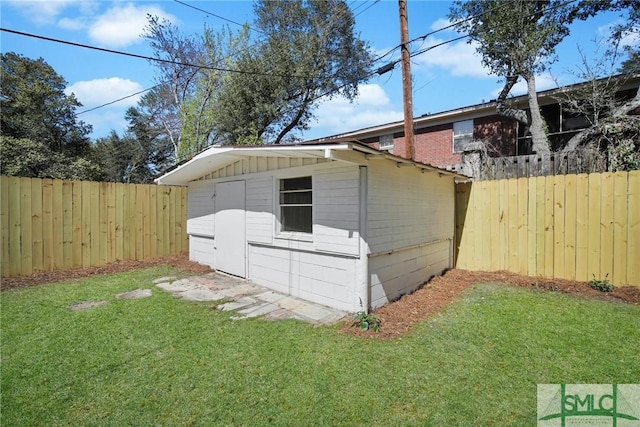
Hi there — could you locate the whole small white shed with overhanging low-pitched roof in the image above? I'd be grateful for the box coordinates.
[156,141,460,312]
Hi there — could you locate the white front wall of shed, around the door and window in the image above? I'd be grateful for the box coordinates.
[188,161,360,311]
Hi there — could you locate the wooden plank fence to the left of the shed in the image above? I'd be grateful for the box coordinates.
[0,176,188,277]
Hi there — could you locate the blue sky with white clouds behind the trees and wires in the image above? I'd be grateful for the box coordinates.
[0,0,638,143]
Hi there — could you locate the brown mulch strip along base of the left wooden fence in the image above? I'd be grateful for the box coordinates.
[0,255,213,289]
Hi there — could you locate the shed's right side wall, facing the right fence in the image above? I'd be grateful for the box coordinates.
[367,162,455,308]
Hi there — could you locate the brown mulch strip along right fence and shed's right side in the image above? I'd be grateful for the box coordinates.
[342,270,640,339]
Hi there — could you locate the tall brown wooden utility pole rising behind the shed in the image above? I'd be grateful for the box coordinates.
[398,0,415,160]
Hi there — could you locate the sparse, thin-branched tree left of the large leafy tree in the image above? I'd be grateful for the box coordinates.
[138,16,240,160]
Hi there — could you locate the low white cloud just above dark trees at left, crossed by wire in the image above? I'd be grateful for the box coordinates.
[65,77,142,109]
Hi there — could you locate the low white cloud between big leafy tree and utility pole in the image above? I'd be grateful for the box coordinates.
[312,84,403,136]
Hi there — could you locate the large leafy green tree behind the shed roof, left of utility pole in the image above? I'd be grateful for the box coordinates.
[217,0,371,144]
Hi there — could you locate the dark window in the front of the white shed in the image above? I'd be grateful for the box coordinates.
[280,176,313,233]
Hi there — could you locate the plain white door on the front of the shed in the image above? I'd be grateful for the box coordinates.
[214,181,247,277]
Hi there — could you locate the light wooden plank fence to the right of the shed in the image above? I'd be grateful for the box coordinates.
[456,171,640,286]
